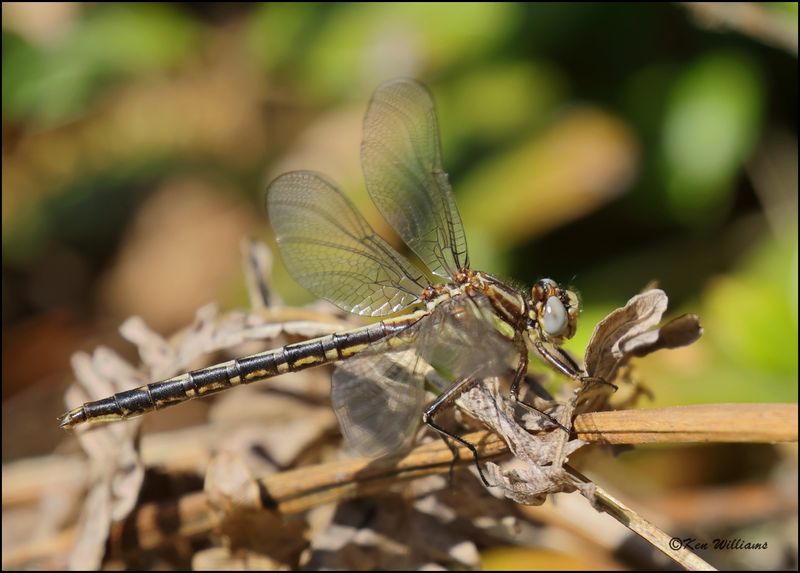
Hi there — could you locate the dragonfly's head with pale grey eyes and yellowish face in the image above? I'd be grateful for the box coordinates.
[529,279,580,344]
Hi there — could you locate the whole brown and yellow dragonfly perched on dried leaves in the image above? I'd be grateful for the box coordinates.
[59,79,586,483]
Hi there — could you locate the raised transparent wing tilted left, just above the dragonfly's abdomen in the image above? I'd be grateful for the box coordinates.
[267,171,427,316]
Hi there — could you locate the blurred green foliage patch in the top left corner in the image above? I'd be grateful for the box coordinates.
[3,4,198,127]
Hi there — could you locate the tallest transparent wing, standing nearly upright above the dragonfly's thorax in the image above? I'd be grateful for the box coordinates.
[361,80,469,278]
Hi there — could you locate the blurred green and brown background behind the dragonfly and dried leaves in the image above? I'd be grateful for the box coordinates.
[2,3,798,459]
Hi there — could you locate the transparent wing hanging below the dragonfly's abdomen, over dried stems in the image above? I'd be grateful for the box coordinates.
[331,349,430,457]
